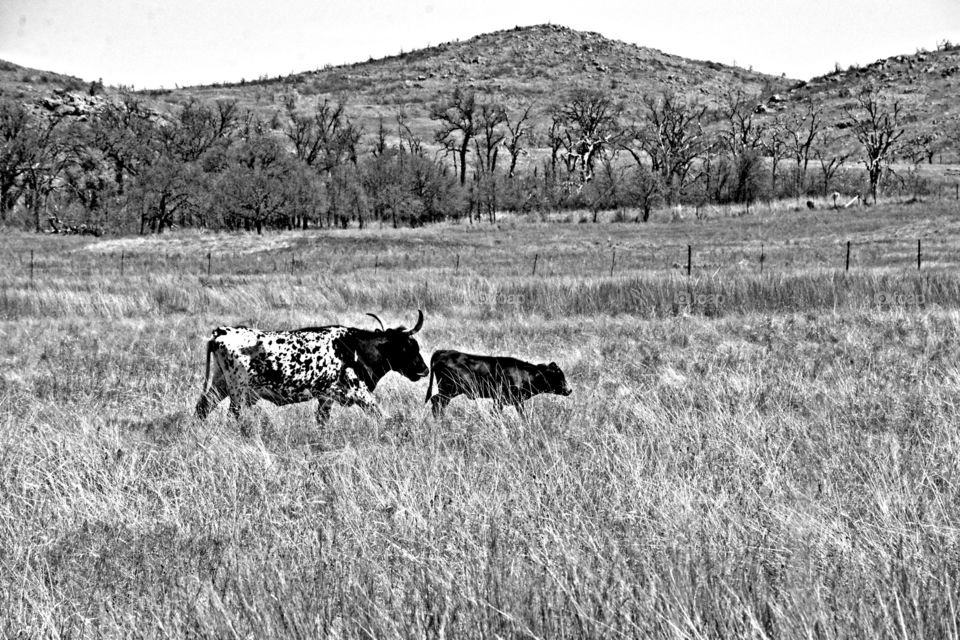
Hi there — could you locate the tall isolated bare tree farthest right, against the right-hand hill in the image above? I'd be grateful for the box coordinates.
[847,87,904,202]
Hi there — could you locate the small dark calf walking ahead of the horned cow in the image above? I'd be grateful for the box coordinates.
[425,350,571,418]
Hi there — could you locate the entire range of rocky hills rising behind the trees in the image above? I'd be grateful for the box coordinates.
[0,24,960,146]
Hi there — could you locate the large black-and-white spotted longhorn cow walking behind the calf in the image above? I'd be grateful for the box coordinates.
[197,311,428,424]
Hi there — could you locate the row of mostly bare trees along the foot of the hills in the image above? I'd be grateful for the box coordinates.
[0,87,948,234]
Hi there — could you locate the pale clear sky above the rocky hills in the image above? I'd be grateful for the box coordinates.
[0,0,960,89]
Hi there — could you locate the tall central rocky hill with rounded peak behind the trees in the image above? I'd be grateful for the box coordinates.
[149,25,796,136]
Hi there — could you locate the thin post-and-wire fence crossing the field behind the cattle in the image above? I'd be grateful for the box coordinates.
[4,238,944,281]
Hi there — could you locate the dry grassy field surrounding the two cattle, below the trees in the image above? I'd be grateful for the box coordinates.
[0,202,960,638]
